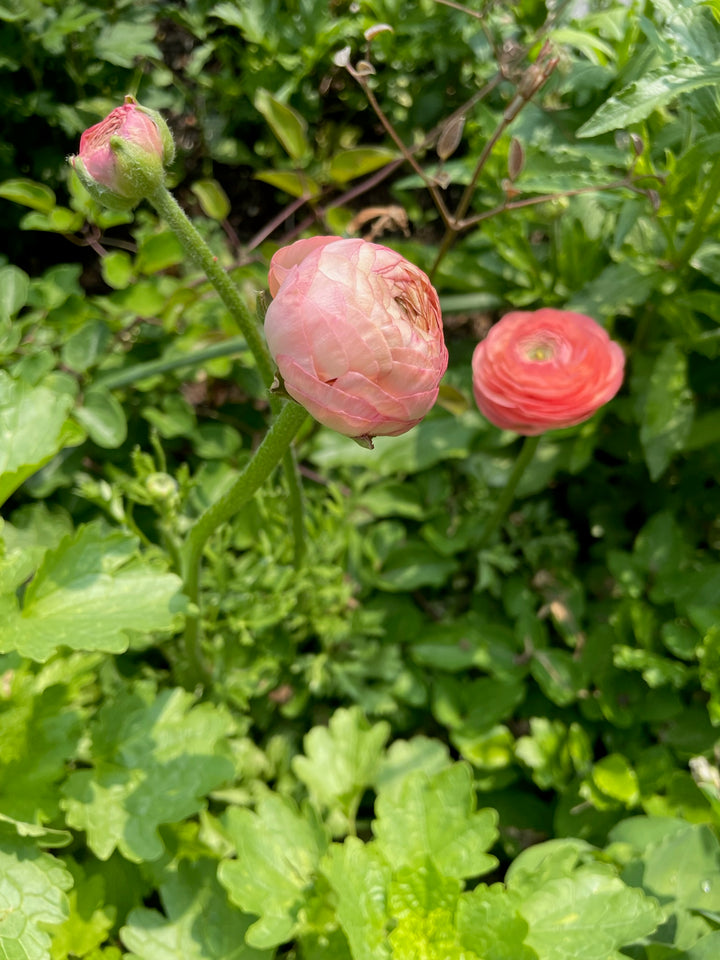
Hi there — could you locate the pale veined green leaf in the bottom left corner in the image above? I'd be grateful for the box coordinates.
[0,835,72,960]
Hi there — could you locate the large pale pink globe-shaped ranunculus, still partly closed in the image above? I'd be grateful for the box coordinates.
[265,237,448,440]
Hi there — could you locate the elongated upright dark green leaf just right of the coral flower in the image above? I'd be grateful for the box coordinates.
[640,341,695,480]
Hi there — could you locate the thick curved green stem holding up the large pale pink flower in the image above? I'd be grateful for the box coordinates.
[181,403,307,681]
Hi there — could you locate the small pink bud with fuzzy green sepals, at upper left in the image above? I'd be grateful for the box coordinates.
[70,97,175,207]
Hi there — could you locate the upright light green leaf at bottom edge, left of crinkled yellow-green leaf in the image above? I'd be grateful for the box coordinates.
[321,837,390,960]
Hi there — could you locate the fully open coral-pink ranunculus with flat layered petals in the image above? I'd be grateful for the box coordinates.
[472,307,625,436]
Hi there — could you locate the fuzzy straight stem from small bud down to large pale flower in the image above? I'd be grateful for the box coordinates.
[148,187,275,387]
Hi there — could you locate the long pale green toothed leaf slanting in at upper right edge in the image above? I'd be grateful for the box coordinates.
[577,60,720,137]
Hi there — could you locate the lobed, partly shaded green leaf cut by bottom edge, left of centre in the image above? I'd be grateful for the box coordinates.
[120,860,271,960]
